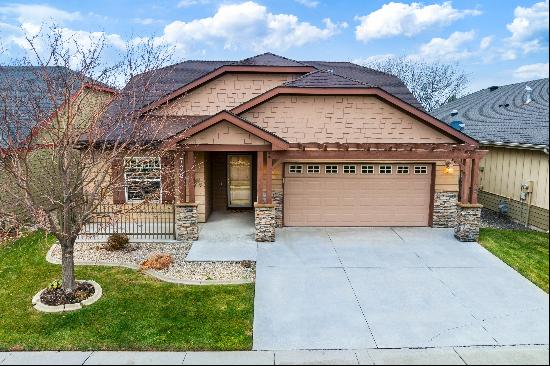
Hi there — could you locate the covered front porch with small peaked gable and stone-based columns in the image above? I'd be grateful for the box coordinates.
[169,112,287,242]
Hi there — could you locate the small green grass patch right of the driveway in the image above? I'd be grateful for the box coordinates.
[479,228,548,292]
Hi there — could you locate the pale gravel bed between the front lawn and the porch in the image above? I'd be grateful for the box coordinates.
[49,242,255,284]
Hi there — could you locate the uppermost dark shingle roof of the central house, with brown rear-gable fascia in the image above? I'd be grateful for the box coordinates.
[112,53,422,112]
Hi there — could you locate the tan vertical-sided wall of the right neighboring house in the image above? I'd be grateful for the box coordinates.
[480,147,548,209]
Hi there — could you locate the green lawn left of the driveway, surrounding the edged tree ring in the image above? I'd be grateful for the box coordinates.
[0,233,254,351]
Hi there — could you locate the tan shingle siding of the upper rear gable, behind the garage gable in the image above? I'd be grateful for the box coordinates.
[154,73,301,116]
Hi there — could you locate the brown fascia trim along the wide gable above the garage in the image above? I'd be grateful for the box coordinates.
[231,85,478,146]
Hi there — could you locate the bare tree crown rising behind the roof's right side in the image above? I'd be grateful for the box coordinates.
[364,57,468,112]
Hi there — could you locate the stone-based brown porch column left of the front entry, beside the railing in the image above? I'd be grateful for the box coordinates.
[175,151,199,241]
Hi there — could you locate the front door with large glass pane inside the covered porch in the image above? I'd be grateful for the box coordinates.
[227,154,252,207]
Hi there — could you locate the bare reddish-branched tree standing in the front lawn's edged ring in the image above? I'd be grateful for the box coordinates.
[0,27,175,292]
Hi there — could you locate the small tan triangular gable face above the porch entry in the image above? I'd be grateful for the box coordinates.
[185,121,269,145]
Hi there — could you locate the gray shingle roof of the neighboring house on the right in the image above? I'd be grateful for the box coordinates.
[431,78,548,147]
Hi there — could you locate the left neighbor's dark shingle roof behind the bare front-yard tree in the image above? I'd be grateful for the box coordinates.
[0,66,114,145]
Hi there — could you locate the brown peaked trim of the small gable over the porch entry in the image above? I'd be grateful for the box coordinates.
[163,111,290,150]
